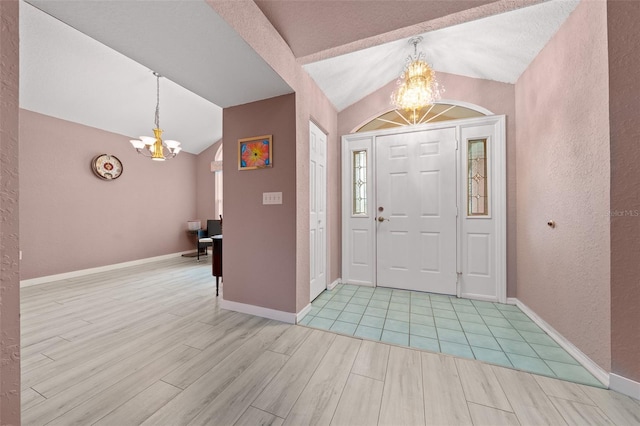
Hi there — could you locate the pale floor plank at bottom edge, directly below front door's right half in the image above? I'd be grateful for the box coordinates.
[421,352,472,425]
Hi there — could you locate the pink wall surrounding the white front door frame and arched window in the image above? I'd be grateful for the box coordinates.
[338,73,517,297]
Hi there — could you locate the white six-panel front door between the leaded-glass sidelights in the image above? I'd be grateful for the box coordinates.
[375,127,457,294]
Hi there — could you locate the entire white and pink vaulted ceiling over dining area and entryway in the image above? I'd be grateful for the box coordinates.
[20,0,578,154]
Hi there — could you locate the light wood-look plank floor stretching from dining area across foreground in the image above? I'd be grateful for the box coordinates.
[22,258,640,426]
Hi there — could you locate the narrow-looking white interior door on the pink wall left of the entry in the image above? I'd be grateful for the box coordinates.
[309,122,327,300]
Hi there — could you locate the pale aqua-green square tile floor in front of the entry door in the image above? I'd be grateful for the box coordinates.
[300,284,603,387]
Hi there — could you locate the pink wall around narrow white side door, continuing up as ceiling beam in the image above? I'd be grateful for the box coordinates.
[208,0,340,312]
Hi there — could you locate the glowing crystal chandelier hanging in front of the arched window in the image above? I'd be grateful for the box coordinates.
[391,37,443,121]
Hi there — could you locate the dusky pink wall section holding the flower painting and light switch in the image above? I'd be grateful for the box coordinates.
[222,94,297,312]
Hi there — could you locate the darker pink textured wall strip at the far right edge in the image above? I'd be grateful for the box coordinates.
[607,1,640,382]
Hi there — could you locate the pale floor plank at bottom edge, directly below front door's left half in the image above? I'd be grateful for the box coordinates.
[378,346,425,425]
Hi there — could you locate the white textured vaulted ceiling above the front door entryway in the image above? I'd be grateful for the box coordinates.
[304,0,578,111]
